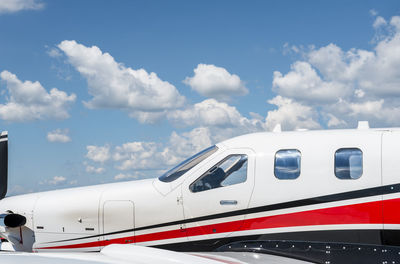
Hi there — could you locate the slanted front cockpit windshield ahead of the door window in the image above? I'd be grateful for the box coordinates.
[158,145,218,182]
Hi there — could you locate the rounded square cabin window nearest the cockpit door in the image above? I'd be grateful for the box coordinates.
[274,149,301,180]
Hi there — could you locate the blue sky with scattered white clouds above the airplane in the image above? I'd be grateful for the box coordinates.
[0,0,400,195]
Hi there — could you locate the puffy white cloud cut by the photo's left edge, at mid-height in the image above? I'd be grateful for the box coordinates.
[0,71,76,122]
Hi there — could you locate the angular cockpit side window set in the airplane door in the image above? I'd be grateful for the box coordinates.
[189,155,247,192]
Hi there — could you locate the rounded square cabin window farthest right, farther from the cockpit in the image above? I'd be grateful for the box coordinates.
[335,148,363,179]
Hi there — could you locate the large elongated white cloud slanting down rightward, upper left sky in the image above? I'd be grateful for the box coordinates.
[58,40,185,122]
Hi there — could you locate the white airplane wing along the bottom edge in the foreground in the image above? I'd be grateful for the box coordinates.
[0,244,311,264]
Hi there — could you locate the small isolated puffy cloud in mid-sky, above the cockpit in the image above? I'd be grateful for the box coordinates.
[183,64,248,100]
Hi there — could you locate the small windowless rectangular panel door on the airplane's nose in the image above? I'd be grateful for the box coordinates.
[103,201,135,246]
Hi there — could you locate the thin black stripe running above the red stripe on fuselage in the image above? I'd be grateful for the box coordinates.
[50,184,400,243]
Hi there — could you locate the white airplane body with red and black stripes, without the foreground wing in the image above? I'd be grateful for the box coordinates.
[0,121,400,263]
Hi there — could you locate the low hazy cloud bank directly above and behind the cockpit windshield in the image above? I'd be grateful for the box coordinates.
[84,127,212,174]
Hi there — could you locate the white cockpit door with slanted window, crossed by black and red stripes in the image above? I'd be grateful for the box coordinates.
[182,149,255,243]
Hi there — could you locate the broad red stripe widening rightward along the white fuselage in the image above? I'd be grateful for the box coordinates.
[35,199,400,249]
